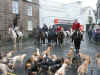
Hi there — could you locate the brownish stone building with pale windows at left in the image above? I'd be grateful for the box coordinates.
[0,0,39,40]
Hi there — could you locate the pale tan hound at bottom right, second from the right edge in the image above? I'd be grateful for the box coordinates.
[77,57,90,75]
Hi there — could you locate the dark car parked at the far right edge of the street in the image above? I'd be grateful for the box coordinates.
[92,25,100,42]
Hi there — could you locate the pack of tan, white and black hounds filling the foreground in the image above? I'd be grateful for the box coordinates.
[0,46,100,75]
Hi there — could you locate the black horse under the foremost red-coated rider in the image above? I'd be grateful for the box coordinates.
[72,30,83,54]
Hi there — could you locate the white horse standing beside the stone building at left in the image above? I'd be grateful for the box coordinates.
[9,27,23,50]
